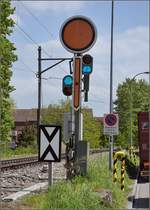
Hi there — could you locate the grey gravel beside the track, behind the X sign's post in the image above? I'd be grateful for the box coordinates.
[0,160,66,199]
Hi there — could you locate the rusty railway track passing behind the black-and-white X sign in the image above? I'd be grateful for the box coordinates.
[0,149,112,171]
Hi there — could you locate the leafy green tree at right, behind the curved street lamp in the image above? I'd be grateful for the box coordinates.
[114,78,149,147]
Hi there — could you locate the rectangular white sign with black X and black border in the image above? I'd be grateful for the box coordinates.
[38,125,61,162]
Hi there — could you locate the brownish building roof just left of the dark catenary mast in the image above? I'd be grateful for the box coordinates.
[13,109,37,122]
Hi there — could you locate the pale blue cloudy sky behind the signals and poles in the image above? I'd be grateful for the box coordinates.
[9,0,149,116]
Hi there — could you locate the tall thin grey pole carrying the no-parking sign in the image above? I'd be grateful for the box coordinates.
[109,0,114,170]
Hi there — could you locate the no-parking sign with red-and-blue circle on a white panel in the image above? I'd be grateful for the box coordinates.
[103,113,119,136]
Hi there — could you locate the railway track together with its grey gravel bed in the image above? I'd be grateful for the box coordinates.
[0,149,117,199]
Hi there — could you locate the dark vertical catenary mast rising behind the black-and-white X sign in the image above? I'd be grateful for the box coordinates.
[37,46,41,143]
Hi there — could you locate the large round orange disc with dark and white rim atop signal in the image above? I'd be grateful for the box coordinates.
[60,16,97,53]
